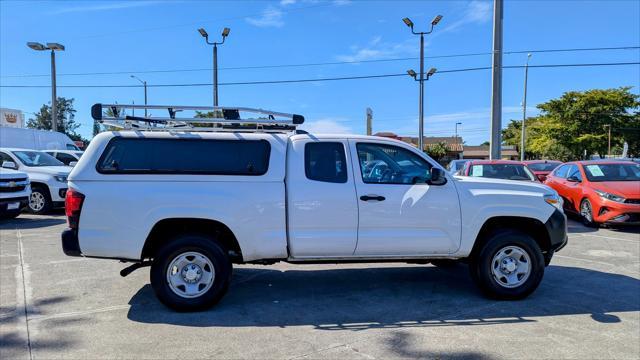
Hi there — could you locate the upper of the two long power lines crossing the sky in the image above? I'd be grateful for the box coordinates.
[0,46,640,78]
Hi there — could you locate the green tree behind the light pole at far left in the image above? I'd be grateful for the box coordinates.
[27,97,84,141]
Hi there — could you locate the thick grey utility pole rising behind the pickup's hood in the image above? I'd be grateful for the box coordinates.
[489,0,503,160]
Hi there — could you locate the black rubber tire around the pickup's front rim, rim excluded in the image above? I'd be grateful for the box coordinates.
[469,230,545,300]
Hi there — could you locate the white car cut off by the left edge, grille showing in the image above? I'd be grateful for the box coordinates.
[0,167,31,219]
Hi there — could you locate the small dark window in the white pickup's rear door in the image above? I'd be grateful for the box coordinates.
[304,142,347,183]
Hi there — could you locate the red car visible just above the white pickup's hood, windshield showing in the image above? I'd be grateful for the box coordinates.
[460,160,538,182]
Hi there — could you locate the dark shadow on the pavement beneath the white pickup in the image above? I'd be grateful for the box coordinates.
[128,265,640,331]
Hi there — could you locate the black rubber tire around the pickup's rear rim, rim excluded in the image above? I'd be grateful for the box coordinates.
[150,234,232,311]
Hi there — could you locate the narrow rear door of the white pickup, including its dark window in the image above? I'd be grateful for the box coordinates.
[286,137,358,258]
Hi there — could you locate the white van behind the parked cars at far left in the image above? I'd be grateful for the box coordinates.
[0,126,80,150]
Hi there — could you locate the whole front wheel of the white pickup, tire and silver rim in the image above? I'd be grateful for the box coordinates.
[469,230,545,300]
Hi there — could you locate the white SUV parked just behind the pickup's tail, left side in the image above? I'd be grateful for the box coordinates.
[0,148,71,214]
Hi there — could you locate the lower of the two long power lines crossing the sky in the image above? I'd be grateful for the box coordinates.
[0,62,640,88]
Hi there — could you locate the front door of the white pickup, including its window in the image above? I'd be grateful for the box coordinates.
[349,140,461,256]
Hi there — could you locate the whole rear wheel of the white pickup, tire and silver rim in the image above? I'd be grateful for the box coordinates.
[151,235,232,311]
